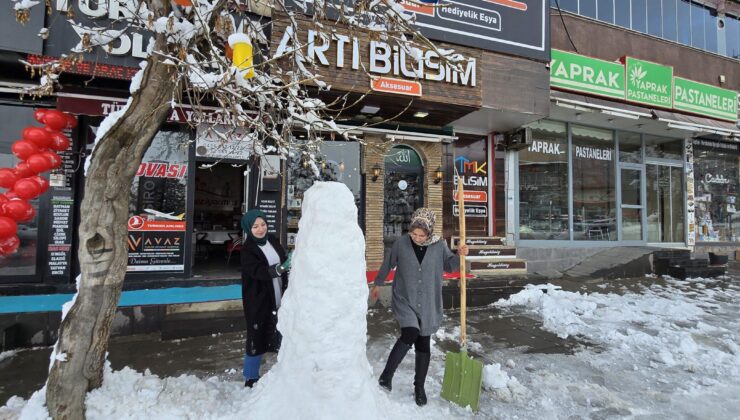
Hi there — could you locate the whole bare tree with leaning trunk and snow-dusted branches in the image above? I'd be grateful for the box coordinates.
[14,0,460,419]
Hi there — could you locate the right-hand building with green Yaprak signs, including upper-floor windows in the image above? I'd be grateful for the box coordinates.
[503,0,740,271]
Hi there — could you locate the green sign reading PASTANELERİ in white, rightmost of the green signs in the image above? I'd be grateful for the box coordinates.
[673,77,737,121]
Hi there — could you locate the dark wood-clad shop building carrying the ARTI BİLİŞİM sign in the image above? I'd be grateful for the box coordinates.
[0,0,550,293]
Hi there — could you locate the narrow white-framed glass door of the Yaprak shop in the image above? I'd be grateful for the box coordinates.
[619,166,645,241]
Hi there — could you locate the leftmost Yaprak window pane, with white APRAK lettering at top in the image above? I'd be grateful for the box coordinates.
[519,120,569,240]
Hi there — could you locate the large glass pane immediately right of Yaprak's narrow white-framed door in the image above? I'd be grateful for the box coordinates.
[646,164,686,243]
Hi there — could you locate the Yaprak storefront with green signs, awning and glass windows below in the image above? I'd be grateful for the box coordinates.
[508,50,739,253]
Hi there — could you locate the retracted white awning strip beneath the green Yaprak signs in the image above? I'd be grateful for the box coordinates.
[550,90,740,139]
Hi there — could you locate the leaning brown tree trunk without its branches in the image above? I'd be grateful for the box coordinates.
[46,42,178,420]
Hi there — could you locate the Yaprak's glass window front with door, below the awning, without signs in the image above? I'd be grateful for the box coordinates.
[517,120,686,246]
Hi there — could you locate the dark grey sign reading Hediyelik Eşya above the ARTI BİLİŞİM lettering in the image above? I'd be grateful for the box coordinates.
[400,0,550,61]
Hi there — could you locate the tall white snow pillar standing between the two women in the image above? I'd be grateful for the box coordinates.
[245,182,388,419]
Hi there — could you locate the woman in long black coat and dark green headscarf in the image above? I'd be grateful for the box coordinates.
[241,210,290,387]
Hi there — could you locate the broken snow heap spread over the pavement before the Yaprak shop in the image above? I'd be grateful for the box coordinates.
[494,282,740,374]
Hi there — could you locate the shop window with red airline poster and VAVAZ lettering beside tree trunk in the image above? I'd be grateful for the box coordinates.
[128,131,189,272]
